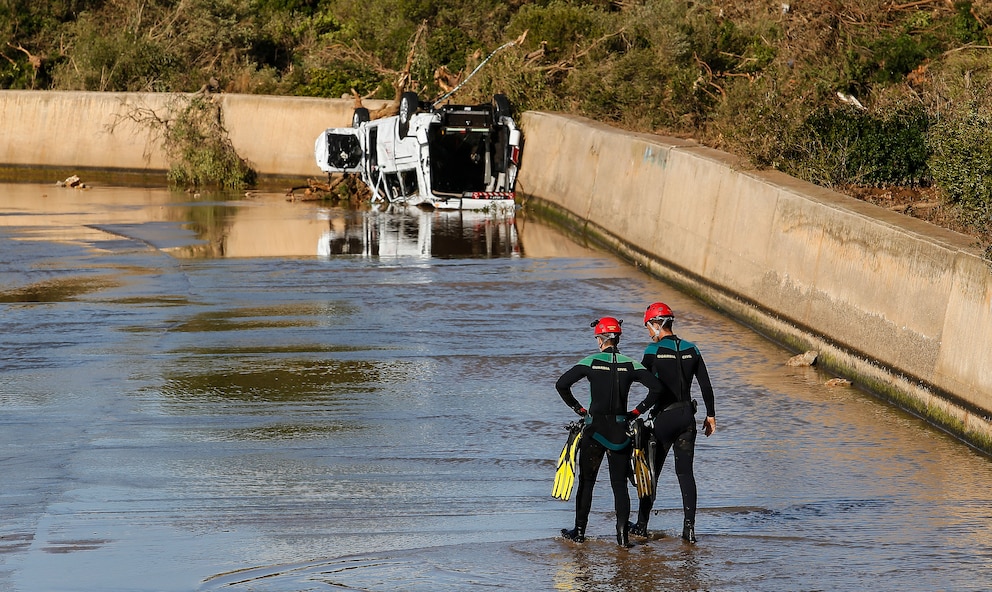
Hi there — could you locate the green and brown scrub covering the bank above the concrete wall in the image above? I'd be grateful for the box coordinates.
[0,0,992,243]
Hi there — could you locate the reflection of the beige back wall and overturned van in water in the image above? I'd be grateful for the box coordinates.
[0,185,521,260]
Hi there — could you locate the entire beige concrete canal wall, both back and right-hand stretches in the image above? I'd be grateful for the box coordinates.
[0,91,992,451]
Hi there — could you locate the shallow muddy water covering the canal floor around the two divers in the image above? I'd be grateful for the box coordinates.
[0,185,992,592]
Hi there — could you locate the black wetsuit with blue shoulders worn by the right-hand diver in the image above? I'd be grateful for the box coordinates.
[637,335,716,527]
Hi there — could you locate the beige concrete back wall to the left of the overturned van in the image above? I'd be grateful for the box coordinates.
[0,91,382,178]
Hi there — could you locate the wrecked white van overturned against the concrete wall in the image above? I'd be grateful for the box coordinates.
[314,92,522,210]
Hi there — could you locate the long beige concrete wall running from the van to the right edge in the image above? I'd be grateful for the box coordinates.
[518,113,992,452]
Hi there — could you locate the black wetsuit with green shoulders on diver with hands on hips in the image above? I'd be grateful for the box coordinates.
[555,347,662,530]
